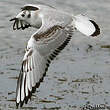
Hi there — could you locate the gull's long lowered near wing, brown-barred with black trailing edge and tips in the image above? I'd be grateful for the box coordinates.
[16,25,72,107]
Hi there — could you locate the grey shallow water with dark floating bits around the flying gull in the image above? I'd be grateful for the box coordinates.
[0,0,110,110]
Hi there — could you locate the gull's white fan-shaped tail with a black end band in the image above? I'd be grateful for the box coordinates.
[73,14,100,37]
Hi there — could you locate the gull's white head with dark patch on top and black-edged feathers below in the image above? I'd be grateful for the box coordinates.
[10,5,41,30]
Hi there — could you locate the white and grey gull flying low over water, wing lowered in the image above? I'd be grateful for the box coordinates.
[10,4,100,108]
